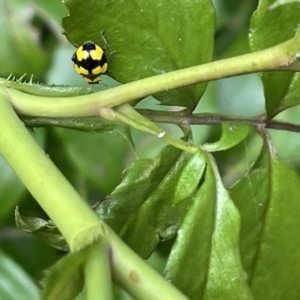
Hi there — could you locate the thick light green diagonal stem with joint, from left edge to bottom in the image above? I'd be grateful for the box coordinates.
[0,91,190,300]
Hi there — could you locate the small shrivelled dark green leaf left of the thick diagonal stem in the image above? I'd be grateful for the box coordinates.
[15,207,69,251]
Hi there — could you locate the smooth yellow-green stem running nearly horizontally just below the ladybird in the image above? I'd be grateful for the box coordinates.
[1,32,300,117]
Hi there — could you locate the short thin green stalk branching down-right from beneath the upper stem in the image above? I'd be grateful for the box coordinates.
[100,104,198,153]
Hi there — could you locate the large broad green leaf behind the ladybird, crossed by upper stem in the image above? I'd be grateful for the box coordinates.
[63,0,215,108]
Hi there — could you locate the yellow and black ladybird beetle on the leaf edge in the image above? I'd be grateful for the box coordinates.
[72,31,108,84]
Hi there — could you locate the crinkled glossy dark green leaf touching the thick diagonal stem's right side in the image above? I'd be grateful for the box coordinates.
[96,146,205,258]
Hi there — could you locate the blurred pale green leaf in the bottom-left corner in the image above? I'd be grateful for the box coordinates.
[0,250,40,300]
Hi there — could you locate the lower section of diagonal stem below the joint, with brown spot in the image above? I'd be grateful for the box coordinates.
[109,232,188,300]
